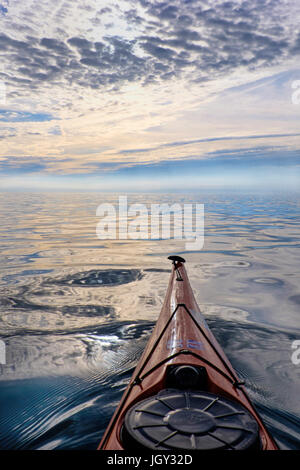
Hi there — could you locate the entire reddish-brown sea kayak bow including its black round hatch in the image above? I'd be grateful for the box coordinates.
[98,256,278,451]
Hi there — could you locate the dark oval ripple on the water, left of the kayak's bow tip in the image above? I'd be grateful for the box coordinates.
[57,269,143,287]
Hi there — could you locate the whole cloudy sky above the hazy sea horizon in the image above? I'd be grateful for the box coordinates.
[0,0,300,190]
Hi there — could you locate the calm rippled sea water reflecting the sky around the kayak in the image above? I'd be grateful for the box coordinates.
[0,191,300,449]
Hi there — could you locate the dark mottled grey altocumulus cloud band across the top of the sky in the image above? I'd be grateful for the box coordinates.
[0,0,300,103]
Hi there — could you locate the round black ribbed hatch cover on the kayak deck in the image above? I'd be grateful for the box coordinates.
[123,389,259,450]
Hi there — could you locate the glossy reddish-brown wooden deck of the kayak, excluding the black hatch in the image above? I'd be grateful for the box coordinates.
[98,257,278,450]
